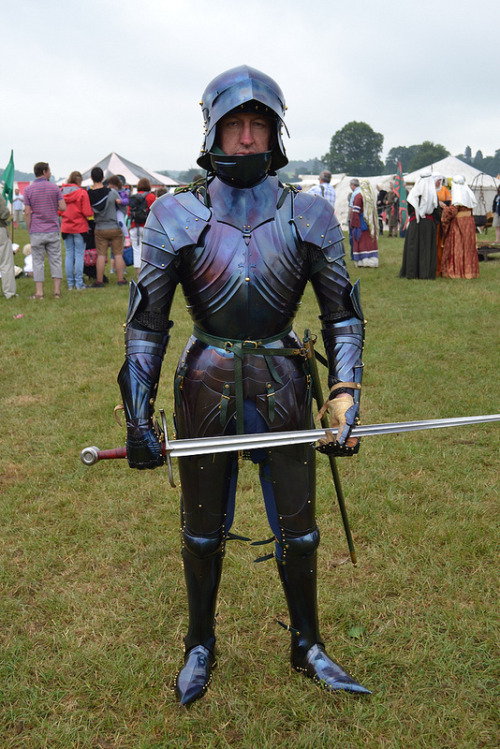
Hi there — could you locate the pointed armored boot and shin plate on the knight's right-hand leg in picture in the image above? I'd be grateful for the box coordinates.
[277,529,371,694]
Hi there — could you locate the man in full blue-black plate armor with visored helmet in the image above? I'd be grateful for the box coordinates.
[118,66,369,705]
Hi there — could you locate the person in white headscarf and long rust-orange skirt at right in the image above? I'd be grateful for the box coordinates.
[441,175,479,278]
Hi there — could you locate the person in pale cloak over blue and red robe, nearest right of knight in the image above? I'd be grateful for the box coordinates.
[350,180,378,268]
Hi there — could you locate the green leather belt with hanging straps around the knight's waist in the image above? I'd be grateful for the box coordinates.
[193,325,307,434]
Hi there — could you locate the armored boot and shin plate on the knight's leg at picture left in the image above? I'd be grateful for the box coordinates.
[175,531,224,705]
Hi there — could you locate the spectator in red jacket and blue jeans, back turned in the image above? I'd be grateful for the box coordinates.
[61,172,92,291]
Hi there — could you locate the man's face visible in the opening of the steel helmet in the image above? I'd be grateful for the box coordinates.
[217,112,271,156]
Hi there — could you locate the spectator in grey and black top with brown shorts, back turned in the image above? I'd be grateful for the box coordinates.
[89,166,127,289]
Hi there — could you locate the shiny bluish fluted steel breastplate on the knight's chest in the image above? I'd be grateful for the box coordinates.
[179,177,309,340]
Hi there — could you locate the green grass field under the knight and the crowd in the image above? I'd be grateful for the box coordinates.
[0,232,500,749]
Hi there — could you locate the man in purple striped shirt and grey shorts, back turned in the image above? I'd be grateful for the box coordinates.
[24,161,66,299]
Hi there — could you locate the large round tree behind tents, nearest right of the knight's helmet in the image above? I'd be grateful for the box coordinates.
[322,122,384,177]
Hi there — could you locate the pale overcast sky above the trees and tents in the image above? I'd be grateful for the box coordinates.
[0,0,500,178]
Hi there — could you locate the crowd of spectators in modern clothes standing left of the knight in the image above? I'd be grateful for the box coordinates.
[0,162,170,300]
